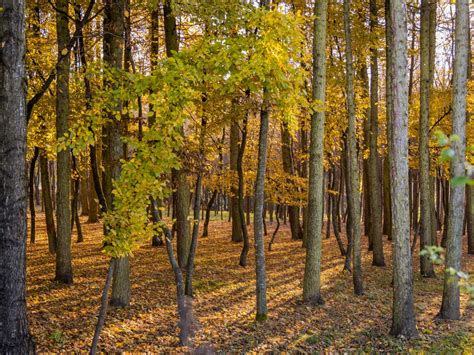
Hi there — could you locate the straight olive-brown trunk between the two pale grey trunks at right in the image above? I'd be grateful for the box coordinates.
[419,0,436,277]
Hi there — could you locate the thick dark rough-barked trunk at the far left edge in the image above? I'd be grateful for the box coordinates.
[0,0,35,354]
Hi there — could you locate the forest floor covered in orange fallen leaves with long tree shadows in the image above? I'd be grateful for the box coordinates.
[27,213,474,354]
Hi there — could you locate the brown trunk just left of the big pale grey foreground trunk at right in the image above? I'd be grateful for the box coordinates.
[367,0,385,266]
